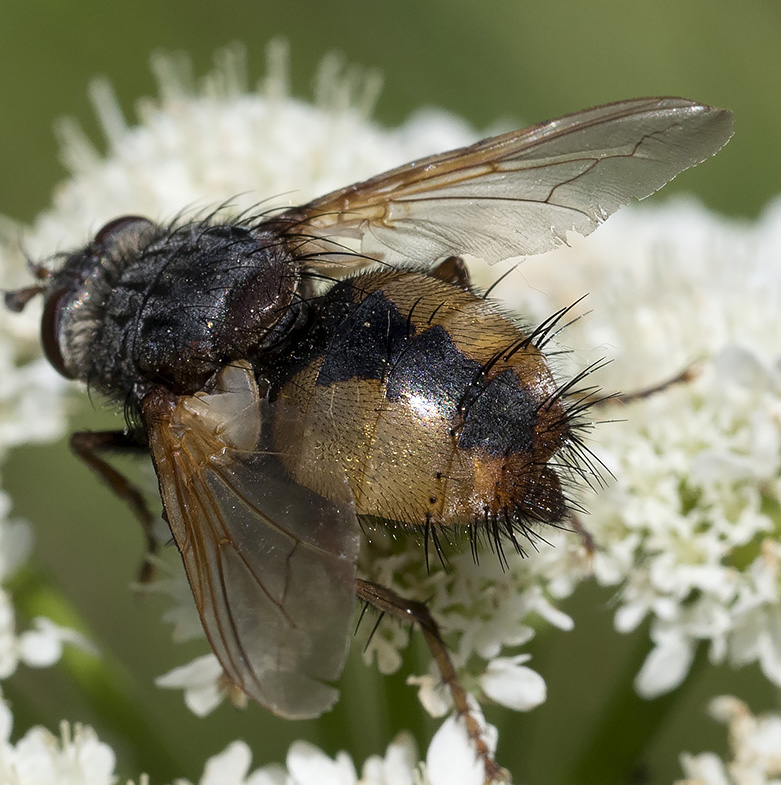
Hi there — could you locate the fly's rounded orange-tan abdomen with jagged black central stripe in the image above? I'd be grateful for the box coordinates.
[275,272,569,525]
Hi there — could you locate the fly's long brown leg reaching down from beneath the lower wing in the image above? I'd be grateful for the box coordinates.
[356,580,509,785]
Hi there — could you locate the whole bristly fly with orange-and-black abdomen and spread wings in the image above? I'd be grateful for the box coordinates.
[6,98,732,759]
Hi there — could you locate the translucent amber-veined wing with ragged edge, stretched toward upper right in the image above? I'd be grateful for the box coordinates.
[282,98,732,267]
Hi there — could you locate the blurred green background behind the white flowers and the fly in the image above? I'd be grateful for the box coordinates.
[0,0,781,783]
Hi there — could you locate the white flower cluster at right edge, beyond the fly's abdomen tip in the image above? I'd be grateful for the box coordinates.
[488,201,781,697]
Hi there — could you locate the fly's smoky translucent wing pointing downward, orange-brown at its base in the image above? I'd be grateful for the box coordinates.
[143,363,359,718]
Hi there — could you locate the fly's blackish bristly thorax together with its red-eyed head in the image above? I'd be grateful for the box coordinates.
[43,217,299,402]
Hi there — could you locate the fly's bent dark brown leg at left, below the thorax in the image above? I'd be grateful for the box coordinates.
[70,431,157,583]
